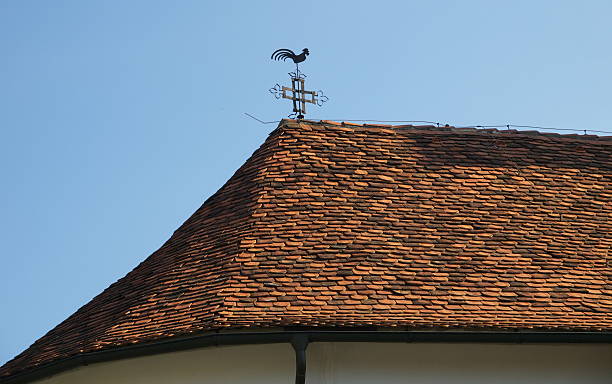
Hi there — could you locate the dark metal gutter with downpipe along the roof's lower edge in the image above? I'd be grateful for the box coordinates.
[0,329,612,384]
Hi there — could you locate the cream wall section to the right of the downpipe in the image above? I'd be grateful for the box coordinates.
[307,343,612,384]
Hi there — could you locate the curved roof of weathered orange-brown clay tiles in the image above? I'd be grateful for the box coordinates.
[0,120,612,377]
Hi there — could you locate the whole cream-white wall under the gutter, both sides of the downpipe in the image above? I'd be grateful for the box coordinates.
[36,343,612,384]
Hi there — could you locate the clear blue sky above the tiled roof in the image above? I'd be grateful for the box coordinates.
[0,0,612,363]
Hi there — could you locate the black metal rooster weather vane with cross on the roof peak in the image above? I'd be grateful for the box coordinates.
[270,48,329,119]
